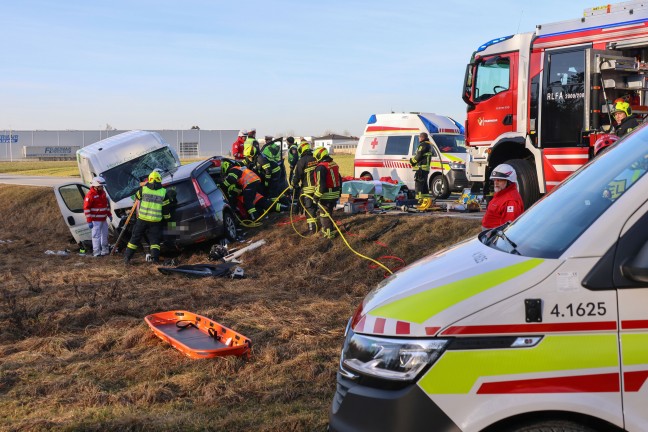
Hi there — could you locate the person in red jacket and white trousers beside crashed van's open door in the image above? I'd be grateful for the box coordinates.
[83,177,112,257]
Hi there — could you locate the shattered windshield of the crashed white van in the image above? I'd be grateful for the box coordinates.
[101,147,176,201]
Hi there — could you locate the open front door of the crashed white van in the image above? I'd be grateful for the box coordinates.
[54,183,92,243]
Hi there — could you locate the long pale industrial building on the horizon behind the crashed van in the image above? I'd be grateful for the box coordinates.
[0,129,238,161]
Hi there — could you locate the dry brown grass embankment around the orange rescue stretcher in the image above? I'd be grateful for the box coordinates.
[0,185,480,431]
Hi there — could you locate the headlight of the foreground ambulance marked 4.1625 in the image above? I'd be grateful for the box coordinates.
[340,331,448,382]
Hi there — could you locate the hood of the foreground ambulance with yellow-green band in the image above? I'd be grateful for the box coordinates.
[353,239,559,337]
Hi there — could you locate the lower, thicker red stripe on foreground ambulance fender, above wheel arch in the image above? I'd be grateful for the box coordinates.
[477,373,619,394]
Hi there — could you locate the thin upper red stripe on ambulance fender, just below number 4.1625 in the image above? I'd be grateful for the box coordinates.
[443,321,617,335]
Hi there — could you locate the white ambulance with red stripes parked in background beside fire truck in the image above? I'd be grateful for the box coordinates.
[354,113,470,198]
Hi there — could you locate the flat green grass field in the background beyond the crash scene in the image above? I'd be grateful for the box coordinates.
[0,154,354,177]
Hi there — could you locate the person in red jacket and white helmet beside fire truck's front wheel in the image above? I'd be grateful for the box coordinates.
[482,164,524,229]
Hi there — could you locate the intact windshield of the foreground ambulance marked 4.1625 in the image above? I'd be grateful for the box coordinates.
[479,128,648,258]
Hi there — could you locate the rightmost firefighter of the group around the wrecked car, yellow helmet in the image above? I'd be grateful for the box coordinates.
[313,147,342,239]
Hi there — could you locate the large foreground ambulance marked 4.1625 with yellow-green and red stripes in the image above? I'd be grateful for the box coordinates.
[329,120,648,432]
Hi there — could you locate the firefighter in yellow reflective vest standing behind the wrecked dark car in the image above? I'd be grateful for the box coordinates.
[124,171,171,264]
